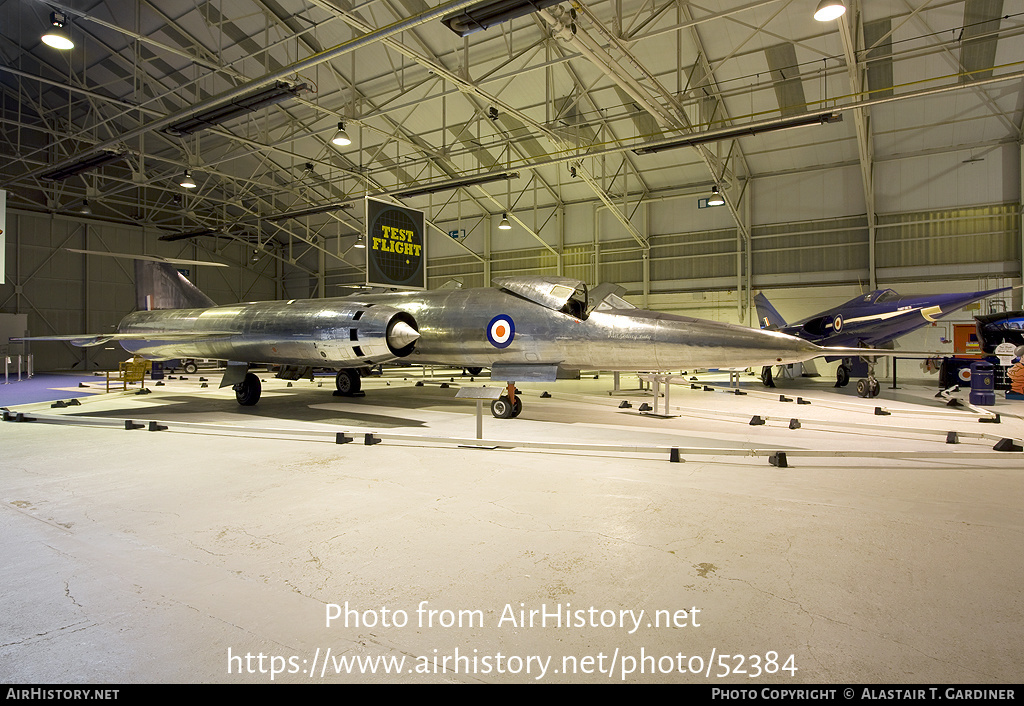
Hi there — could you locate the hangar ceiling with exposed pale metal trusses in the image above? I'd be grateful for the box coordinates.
[0,0,1024,285]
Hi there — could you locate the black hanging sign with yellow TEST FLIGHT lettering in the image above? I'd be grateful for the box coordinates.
[367,198,427,289]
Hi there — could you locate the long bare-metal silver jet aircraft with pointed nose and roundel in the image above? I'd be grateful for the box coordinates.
[18,261,888,418]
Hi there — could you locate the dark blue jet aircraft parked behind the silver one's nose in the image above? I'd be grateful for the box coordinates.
[754,287,1014,398]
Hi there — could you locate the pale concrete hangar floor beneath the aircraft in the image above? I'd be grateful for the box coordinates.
[0,374,1024,687]
